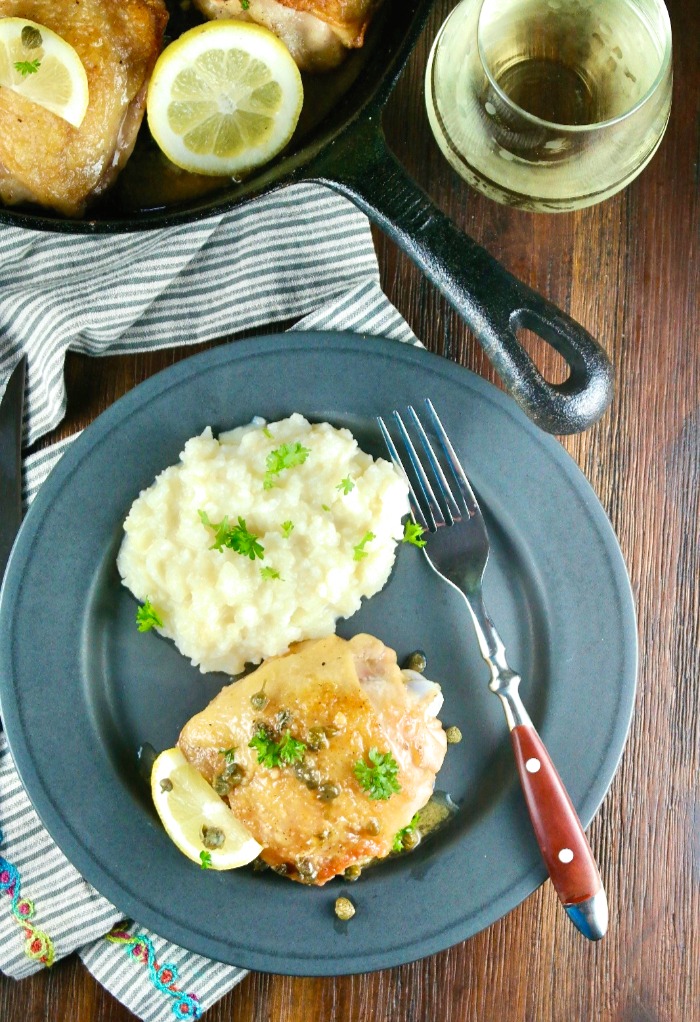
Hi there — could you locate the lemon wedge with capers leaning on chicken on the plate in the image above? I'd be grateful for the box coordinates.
[150,748,263,870]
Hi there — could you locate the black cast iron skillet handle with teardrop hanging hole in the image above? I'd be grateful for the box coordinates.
[305,115,613,433]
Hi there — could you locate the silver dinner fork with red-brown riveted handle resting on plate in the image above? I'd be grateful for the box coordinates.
[377,399,608,940]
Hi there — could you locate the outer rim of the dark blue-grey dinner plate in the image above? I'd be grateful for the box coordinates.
[0,331,638,976]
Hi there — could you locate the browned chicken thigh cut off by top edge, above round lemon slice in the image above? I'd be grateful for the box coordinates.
[194,0,379,72]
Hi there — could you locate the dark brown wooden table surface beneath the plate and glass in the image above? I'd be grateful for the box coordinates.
[0,0,700,1022]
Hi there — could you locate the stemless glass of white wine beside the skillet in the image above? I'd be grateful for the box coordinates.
[425,0,672,212]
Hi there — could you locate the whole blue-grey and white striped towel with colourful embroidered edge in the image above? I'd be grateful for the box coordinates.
[0,185,418,1022]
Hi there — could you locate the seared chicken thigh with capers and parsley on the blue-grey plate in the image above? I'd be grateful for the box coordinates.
[178,635,447,884]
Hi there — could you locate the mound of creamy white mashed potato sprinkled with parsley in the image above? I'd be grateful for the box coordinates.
[118,414,409,675]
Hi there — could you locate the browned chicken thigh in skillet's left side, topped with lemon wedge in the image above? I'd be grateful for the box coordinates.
[0,0,168,216]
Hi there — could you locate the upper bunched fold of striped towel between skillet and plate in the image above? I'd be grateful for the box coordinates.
[0,184,379,446]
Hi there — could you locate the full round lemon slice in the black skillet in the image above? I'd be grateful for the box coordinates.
[146,20,304,176]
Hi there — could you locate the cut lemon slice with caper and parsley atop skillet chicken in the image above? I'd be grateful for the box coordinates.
[0,17,89,128]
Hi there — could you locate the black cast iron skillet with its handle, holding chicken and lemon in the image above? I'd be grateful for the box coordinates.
[0,0,612,433]
